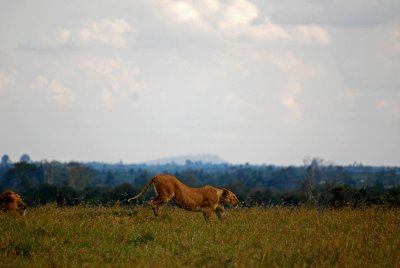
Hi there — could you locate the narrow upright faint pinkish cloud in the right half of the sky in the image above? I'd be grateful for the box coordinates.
[281,81,302,127]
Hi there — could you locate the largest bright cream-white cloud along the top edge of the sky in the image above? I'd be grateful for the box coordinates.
[162,0,330,45]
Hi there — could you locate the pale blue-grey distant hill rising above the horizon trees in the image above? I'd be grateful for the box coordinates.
[146,154,226,165]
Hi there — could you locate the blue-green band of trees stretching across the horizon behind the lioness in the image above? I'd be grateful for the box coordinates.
[0,155,400,208]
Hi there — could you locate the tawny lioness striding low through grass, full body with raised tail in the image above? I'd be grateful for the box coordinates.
[128,174,239,220]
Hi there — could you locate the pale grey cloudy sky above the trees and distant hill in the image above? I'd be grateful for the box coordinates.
[0,0,400,165]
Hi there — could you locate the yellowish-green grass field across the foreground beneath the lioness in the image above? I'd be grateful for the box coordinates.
[0,206,400,267]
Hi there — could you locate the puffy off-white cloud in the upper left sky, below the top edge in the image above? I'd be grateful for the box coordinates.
[78,19,133,48]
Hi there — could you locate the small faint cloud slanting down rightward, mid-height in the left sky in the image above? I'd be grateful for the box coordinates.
[35,75,76,106]
